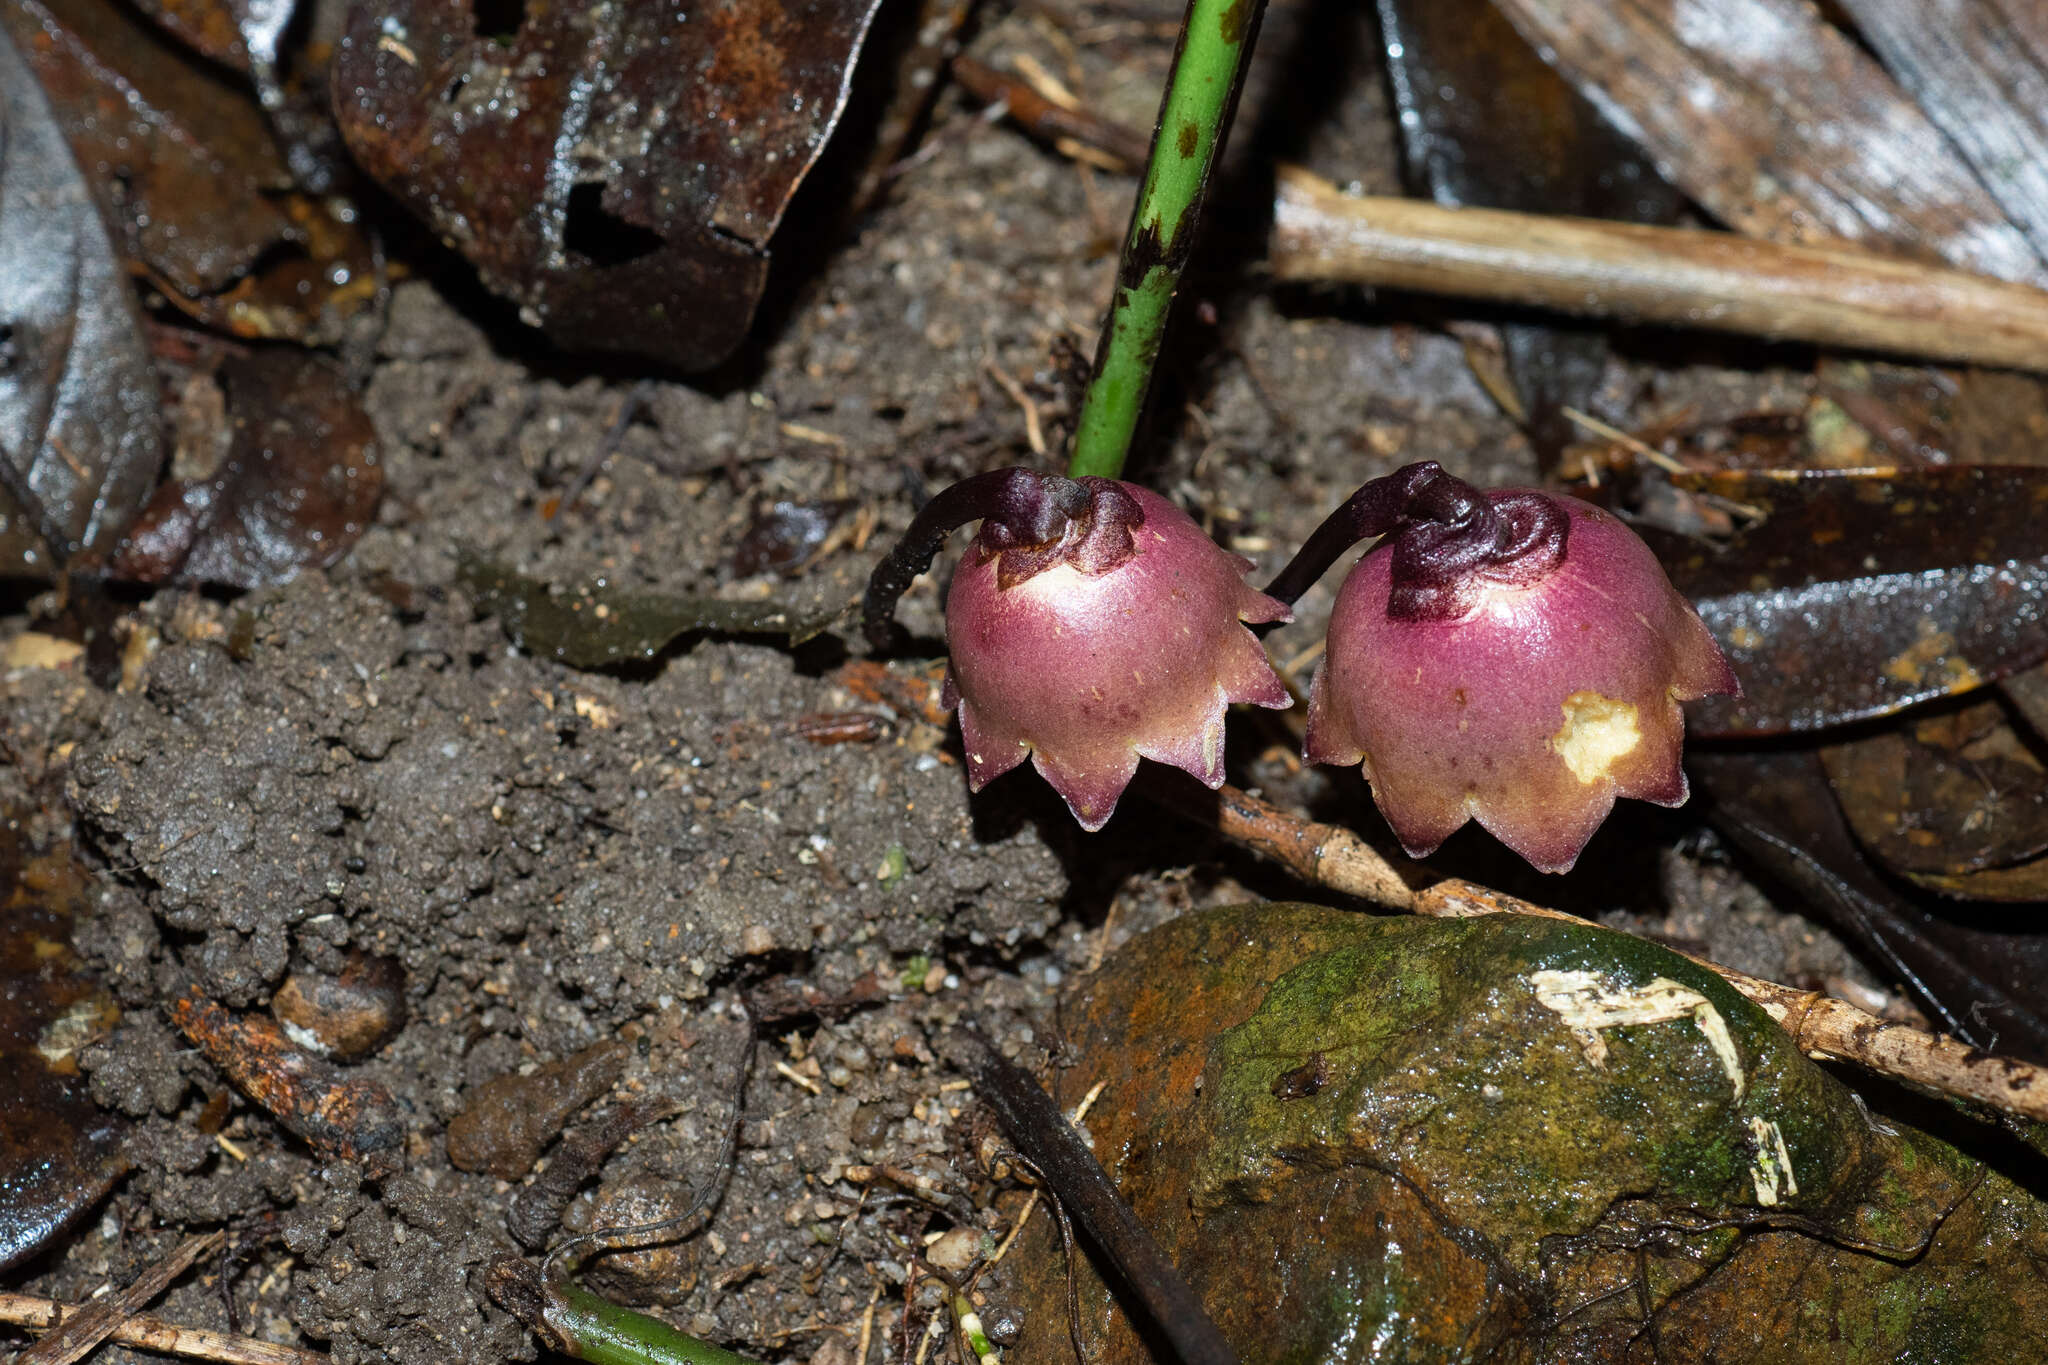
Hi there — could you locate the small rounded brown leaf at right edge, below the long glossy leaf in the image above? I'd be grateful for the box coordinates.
[1821,700,2048,900]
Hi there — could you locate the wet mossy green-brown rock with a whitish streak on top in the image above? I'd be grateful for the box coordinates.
[1006,905,2048,1365]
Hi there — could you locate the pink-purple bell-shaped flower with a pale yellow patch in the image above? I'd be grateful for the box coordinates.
[1272,465,1739,872]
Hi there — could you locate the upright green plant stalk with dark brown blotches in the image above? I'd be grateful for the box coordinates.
[1067,0,1266,479]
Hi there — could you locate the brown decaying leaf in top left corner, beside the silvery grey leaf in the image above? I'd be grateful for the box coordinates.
[0,0,375,342]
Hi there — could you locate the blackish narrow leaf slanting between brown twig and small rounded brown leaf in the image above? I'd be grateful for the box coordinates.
[1686,747,2048,1062]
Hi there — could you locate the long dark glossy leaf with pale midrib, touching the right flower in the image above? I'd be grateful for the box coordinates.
[1645,465,2048,735]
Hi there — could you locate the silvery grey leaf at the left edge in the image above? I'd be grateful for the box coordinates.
[0,29,162,575]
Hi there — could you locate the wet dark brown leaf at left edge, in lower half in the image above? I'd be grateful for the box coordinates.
[0,826,127,1269]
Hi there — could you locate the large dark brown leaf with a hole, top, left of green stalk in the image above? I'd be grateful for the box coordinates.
[334,0,879,368]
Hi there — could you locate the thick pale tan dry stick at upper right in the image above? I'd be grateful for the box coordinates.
[1270,168,2048,370]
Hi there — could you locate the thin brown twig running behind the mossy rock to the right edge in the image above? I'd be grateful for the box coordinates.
[1147,782,2048,1121]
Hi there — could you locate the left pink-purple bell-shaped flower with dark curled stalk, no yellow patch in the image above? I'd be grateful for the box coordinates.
[866,469,1292,831]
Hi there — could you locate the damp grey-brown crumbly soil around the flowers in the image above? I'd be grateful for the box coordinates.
[0,4,1892,1365]
